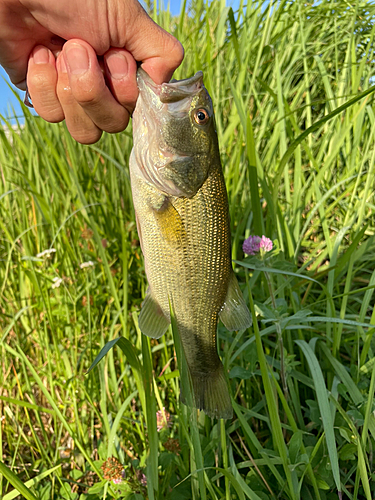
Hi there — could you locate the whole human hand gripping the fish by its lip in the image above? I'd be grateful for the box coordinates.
[0,0,183,144]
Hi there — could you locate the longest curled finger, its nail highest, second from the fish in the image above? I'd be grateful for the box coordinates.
[62,39,134,133]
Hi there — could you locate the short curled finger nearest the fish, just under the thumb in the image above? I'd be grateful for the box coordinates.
[104,49,138,114]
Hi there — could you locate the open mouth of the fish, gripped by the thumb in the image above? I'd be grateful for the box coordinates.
[137,68,203,105]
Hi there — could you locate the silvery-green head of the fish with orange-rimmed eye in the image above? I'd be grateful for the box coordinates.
[133,68,219,197]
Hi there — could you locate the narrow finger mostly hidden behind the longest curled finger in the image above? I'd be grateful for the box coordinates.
[56,53,102,144]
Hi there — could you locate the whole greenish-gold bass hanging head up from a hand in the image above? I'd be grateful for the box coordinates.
[129,68,252,419]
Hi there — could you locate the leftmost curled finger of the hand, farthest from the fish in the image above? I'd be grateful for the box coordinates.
[27,45,64,123]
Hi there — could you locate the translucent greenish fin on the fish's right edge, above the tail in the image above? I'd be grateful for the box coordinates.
[219,273,252,331]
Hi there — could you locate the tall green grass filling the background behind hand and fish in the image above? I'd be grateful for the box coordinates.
[0,0,375,500]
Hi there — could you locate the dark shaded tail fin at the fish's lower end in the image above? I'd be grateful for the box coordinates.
[181,363,233,419]
